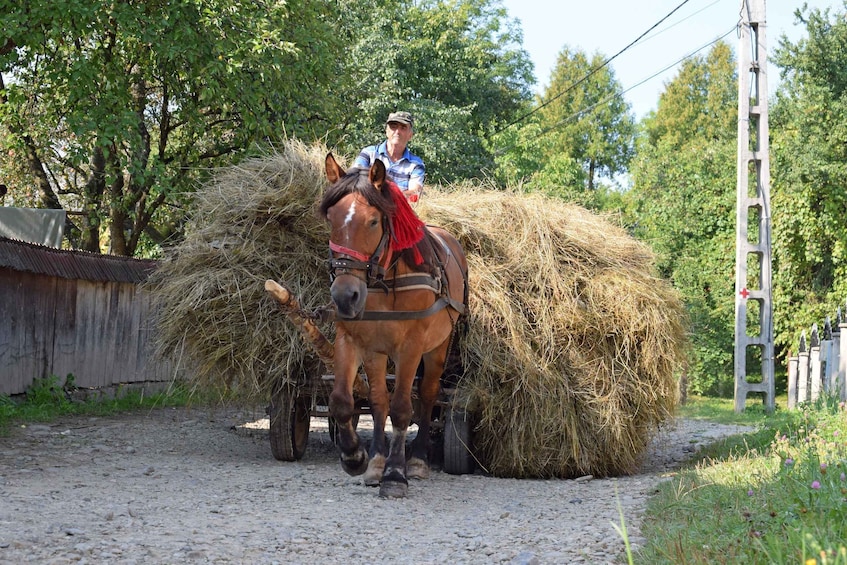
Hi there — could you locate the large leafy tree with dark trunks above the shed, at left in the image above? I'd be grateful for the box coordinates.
[0,0,341,255]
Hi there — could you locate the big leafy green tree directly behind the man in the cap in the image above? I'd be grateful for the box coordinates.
[333,0,532,182]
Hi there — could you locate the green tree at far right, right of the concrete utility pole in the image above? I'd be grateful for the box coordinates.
[770,4,847,351]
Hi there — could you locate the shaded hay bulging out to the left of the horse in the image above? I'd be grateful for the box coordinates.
[150,140,329,400]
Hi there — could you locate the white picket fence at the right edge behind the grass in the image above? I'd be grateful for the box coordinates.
[788,308,847,409]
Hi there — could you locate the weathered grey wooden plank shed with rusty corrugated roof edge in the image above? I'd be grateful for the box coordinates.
[0,237,171,395]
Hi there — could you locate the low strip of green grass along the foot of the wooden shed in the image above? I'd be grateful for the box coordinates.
[0,376,198,436]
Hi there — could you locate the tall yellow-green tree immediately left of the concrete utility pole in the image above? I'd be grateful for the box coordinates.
[626,42,738,395]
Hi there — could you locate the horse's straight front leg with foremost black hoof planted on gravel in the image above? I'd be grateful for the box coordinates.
[379,353,420,498]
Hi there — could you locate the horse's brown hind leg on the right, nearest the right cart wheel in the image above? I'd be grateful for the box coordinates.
[406,338,450,479]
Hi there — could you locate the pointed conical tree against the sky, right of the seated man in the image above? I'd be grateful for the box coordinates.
[533,46,635,199]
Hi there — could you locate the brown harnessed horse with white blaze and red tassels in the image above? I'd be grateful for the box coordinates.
[319,153,468,498]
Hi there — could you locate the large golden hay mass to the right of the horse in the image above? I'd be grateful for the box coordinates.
[418,191,685,477]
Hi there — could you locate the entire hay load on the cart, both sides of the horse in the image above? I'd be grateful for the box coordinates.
[153,141,685,477]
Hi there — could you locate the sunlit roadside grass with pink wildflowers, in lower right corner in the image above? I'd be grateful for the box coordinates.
[635,398,847,565]
